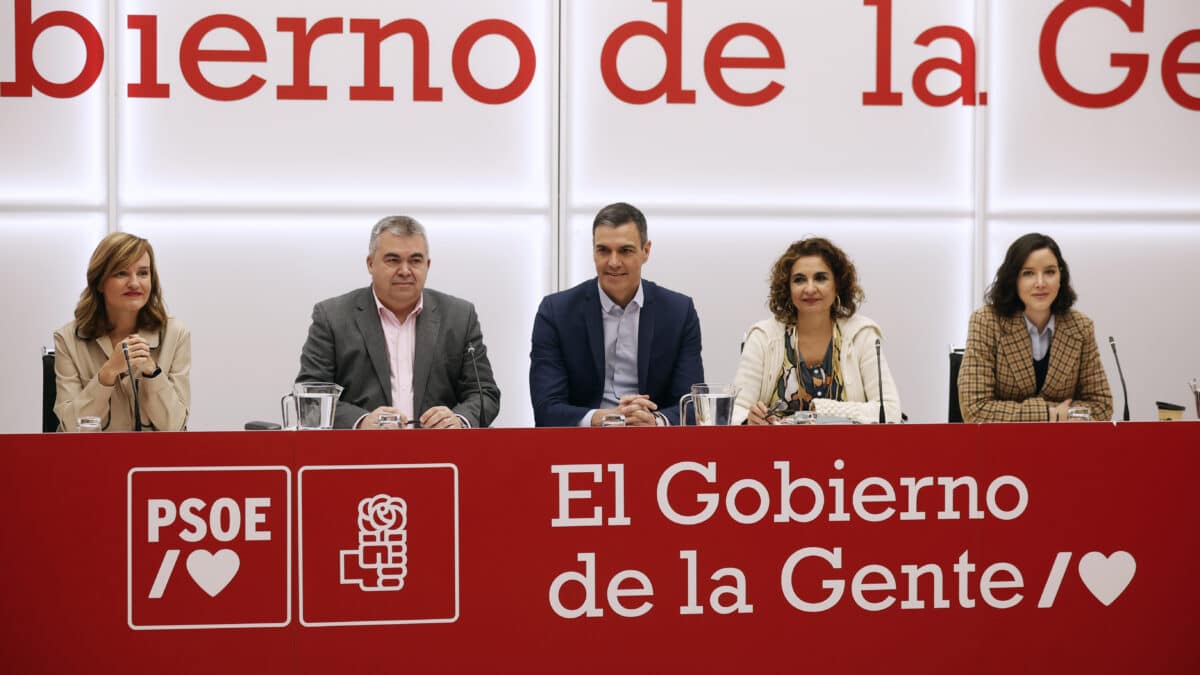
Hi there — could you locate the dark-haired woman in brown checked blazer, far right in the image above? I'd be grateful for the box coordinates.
[959,233,1112,423]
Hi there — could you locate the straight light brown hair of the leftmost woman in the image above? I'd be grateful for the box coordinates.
[76,232,167,340]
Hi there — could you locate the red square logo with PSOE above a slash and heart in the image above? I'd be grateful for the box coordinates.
[126,466,292,631]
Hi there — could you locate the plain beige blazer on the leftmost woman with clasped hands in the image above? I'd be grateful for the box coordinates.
[54,317,192,431]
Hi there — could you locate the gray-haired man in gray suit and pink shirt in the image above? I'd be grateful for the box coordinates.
[296,216,500,429]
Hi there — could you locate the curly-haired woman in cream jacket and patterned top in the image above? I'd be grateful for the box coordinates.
[733,237,900,424]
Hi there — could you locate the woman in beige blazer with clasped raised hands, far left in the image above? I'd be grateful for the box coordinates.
[54,232,192,431]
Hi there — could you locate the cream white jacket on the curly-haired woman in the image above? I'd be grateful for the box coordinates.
[733,315,900,424]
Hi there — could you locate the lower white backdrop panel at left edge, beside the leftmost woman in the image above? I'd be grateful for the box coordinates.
[0,213,104,434]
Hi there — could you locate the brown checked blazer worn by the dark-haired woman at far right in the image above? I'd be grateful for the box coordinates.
[959,305,1112,422]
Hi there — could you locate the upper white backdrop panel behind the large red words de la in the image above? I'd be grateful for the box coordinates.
[564,0,973,209]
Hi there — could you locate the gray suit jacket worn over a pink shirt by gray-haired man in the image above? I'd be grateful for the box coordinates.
[296,286,500,429]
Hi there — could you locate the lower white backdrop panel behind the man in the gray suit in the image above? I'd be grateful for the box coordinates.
[121,213,550,430]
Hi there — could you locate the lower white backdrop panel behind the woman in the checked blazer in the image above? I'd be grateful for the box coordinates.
[988,221,1200,419]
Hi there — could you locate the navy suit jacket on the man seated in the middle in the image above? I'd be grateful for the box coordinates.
[529,277,704,426]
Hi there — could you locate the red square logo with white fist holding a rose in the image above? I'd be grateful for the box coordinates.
[296,464,458,626]
